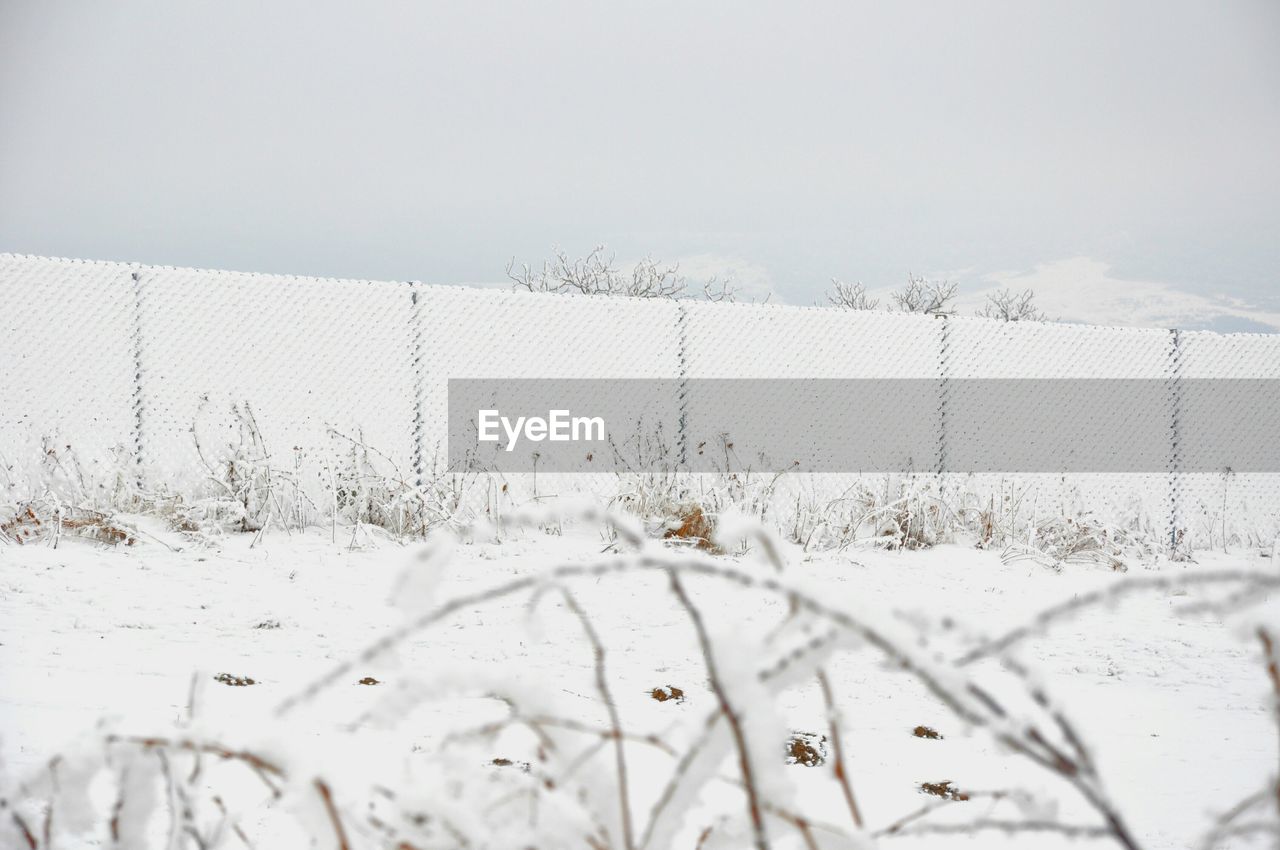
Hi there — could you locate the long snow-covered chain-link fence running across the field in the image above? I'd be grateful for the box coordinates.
[0,249,1280,545]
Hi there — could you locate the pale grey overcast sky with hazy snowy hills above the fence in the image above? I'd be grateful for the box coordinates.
[0,0,1280,330]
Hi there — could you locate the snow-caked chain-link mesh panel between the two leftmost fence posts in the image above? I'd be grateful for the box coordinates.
[138,262,413,490]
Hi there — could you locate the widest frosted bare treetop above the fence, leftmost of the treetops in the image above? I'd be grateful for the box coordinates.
[507,245,733,301]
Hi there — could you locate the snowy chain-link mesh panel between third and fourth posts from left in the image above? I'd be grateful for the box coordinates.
[682,303,942,541]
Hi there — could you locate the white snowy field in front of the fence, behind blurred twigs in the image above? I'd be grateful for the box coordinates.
[0,506,1277,849]
